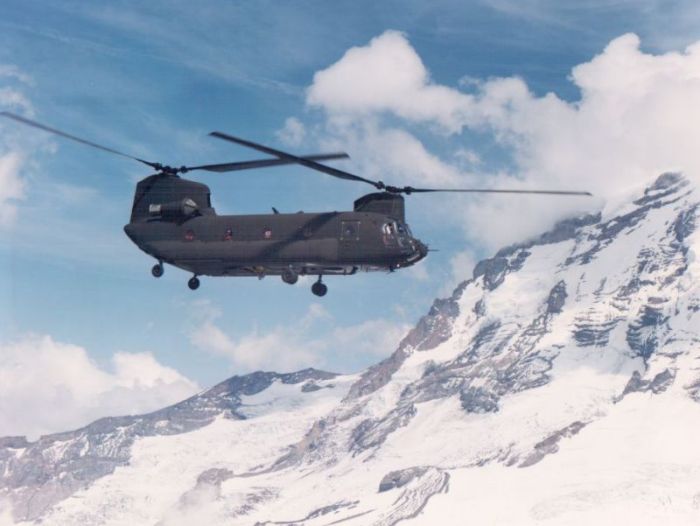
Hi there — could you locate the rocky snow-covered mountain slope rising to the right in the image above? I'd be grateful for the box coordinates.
[0,174,700,526]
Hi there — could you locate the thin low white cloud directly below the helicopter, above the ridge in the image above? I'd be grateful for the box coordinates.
[189,303,410,372]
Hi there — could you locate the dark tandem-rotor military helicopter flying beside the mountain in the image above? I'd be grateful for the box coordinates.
[0,112,591,297]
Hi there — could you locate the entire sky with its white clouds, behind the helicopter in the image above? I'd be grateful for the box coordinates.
[0,0,700,442]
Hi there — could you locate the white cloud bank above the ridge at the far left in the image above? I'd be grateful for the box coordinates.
[0,336,198,438]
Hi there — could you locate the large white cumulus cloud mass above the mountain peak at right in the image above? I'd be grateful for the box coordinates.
[307,31,700,249]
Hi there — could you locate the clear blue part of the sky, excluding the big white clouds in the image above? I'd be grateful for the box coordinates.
[0,0,700,432]
